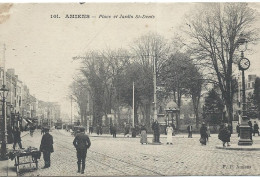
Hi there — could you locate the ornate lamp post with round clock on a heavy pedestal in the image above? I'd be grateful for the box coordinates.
[237,35,252,145]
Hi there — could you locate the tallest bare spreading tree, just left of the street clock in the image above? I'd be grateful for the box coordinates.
[187,3,257,124]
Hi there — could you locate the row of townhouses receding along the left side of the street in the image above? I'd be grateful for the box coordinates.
[0,68,60,137]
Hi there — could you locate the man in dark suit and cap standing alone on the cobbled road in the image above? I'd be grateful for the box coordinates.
[73,127,91,174]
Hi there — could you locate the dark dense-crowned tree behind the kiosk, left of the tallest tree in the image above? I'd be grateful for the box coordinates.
[159,52,202,129]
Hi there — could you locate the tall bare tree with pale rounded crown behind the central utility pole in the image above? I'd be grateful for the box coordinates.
[131,33,169,126]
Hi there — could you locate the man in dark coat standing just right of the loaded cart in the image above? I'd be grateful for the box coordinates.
[40,128,54,168]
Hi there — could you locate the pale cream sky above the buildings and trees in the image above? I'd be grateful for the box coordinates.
[0,3,260,117]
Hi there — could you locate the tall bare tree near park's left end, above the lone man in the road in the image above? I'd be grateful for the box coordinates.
[81,51,111,126]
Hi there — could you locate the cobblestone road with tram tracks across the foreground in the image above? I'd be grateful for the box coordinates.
[2,130,260,176]
